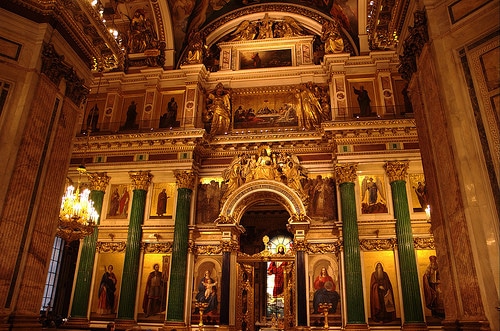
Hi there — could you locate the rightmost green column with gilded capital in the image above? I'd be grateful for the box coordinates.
[384,161,425,329]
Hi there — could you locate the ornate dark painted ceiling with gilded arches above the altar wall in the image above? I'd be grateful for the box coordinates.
[0,0,409,71]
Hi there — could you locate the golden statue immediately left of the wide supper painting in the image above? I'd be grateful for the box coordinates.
[207,83,231,135]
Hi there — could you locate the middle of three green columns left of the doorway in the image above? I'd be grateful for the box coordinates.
[117,171,153,325]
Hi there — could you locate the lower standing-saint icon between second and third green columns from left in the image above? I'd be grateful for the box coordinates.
[137,254,170,321]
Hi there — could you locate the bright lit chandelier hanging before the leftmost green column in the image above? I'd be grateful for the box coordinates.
[57,165,99,244]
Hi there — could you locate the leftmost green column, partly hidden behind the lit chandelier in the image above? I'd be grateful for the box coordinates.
[69,172,110,325]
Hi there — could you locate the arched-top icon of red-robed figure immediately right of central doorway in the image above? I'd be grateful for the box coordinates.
[309,253,341,327]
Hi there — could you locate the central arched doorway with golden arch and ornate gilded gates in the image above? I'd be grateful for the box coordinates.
[218,180,309,331]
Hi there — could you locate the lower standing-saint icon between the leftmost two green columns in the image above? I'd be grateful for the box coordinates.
[90,253,125,320]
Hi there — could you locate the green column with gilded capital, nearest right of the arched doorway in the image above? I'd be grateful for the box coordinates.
[335,164,368,330]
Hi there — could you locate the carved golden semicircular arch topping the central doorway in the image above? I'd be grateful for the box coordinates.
[219,180,307,224]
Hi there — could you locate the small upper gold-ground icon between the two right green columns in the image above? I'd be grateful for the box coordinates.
[358,175,388,214]
